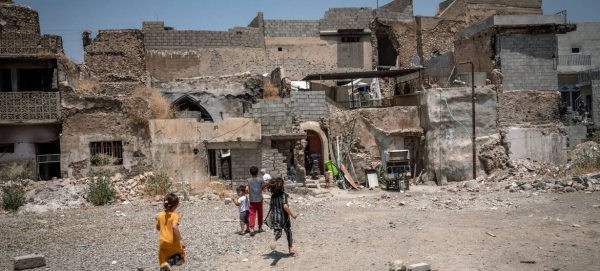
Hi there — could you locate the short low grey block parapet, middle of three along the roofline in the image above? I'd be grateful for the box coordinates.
[265,20,319,37]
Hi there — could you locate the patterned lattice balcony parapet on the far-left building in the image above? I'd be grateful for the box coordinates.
[0,92,60,124]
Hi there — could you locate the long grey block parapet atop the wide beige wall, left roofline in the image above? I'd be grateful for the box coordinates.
[142,22,265,48]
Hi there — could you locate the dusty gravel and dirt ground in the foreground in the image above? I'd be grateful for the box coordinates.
[0,187,600,271]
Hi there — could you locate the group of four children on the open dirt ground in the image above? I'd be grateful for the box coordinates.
[156,166,298,271]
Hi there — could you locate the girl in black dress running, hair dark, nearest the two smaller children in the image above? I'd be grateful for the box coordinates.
[267,177,298,254]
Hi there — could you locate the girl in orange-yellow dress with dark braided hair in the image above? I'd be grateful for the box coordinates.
[156,193,186,271]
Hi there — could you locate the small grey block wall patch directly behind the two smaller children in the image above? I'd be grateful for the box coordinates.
[231,149,262,187]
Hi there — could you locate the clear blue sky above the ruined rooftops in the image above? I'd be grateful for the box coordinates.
[14,0,600,62]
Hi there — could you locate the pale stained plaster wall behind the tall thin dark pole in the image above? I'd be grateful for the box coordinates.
[421,87,500,185]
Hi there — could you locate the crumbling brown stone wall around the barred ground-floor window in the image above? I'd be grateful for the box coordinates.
[60,89,152,178]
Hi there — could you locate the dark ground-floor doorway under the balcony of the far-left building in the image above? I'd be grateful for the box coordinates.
[35,140,61,181]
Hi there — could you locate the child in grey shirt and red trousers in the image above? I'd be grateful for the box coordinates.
[246,166,264,236]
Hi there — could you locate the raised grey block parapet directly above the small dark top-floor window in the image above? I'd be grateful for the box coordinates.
[319,8,373,31]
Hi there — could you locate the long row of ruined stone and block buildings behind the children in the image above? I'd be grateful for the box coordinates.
[0,0,600,191]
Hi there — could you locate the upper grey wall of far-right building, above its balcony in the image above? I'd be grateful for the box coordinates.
[557,22,600,73]
